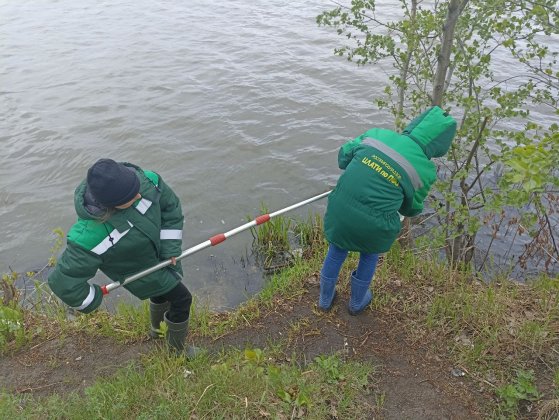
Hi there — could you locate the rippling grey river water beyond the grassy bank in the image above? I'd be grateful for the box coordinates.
[0,0,556,309]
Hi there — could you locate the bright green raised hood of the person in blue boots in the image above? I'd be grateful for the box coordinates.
[402,106,456,159]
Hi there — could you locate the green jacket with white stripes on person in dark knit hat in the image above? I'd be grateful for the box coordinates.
[48,163,184,313]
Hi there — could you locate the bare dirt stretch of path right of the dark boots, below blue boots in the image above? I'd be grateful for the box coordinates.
[205,277,485,420]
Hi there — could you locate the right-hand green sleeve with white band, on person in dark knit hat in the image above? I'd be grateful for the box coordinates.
[159,177,184,259]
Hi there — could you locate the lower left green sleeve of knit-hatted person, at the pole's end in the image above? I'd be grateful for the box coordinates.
[48,242,103,313]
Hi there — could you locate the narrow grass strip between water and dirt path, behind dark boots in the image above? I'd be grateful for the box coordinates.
[0,216,325,351]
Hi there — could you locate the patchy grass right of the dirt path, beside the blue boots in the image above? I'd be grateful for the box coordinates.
[373,244,559,418]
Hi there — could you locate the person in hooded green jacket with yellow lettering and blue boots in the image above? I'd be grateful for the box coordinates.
[318,106,456,315]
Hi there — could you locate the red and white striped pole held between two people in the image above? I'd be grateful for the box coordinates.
[101,191,332,295]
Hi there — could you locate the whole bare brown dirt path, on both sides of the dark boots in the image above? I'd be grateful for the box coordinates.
[0,277,490,420]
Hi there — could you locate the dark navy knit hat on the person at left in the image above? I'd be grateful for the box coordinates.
[87,159,140,207]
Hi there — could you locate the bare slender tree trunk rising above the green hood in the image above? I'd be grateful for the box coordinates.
[432,0,469,106]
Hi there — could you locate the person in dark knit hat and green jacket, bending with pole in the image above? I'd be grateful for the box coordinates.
[48,159,198,355]
